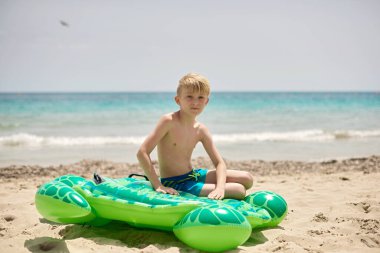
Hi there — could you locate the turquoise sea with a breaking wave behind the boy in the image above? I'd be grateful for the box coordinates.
[0,92,380,165]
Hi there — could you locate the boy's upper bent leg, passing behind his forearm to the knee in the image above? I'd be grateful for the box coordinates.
[205,170,253,192]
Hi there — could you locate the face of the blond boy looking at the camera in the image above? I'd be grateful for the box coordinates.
[175,89,209,115]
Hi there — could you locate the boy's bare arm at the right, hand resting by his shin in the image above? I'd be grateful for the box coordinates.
[201,126,226,199]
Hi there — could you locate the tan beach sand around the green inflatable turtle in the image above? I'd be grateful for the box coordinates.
[0,156,380,253]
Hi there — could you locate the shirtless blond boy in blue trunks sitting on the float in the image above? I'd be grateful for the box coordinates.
[137,73,253,199]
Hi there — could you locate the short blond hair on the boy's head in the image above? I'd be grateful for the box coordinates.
[177,73,210,96]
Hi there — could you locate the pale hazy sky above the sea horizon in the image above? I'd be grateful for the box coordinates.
[0,0,380,92]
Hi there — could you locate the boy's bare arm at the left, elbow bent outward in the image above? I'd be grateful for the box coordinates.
[137,116,178,194]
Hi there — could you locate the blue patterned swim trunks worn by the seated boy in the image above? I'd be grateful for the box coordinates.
[161,169,207,196]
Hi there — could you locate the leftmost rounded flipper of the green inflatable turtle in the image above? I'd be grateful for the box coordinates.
[35,175,96,223]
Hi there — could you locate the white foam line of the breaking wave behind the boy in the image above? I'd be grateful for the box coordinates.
[0,129,380,146]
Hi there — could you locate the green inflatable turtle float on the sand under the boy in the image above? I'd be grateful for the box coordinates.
[35,175,287,252]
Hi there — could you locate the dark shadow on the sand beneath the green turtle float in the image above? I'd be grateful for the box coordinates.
[24,219,267,253]
